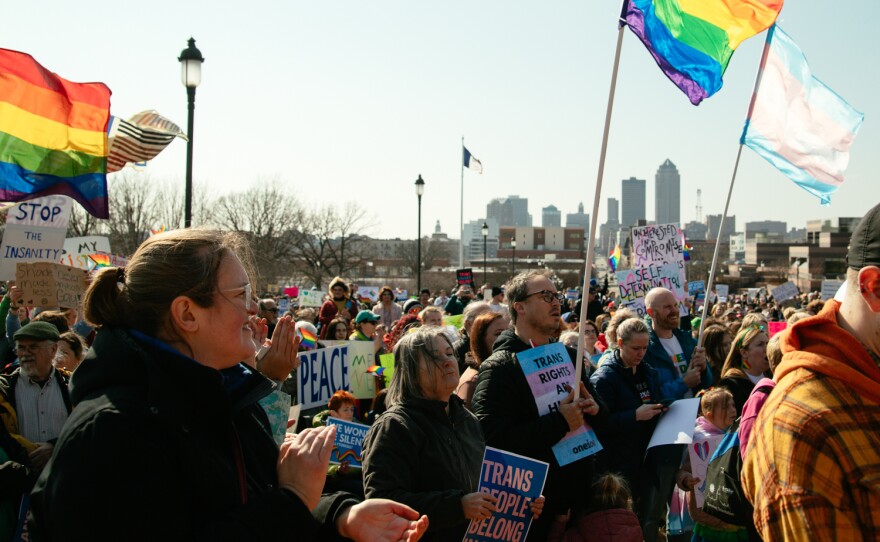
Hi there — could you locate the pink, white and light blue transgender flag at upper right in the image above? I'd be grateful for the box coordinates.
[740,25,865,205]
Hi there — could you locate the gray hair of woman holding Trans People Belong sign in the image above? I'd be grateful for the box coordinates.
[385,327,452,407]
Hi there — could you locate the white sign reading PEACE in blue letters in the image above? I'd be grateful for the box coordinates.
[297,344,350,409]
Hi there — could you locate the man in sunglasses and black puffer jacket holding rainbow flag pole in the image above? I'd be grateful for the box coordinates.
[473,271,608,541]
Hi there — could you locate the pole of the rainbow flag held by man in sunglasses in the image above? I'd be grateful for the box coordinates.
[574,17,627,399]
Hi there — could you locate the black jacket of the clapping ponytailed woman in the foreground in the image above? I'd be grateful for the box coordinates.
[29,328,356,541]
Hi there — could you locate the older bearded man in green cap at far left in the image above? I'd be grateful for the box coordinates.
[0,322,71,469]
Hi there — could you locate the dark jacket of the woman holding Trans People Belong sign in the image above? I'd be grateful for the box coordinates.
[363,395,485,542]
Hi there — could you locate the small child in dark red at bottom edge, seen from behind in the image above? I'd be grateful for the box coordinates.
[547,473,643,542]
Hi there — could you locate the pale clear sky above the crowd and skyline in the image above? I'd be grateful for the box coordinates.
[0,0,880,238]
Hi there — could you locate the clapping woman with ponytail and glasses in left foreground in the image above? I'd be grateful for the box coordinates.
[28,228,427,542]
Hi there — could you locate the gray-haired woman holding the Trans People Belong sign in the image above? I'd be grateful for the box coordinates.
[363,327,496,541]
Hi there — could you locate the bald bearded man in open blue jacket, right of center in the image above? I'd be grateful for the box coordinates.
[636,288,712,542]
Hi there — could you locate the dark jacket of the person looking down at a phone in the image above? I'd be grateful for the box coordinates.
[590,350,661,490]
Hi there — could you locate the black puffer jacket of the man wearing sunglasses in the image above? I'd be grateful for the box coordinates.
[472,330,608,521]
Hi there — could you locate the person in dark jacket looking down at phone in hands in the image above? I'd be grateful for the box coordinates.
[590,318,663,509]
